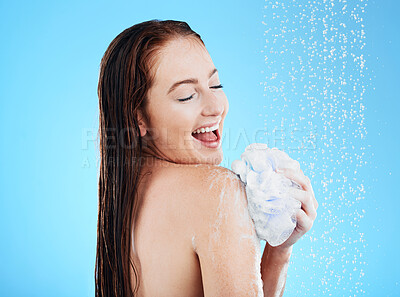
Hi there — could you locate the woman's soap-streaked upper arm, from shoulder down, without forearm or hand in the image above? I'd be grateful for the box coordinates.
[190,168,263,297]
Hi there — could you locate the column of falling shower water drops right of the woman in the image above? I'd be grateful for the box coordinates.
[261,0,370,296]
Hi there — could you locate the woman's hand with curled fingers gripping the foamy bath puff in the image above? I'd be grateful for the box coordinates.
[270,168,318,251]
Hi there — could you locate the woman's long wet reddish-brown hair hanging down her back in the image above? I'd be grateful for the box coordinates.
[95,20,204,297]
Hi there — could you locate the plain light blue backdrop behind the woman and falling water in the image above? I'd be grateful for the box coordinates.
[0,0,400,297]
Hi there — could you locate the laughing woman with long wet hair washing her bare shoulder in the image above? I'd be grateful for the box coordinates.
[96,20,317,296]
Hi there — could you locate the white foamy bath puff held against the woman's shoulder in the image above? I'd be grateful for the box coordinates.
[231,143,301,246]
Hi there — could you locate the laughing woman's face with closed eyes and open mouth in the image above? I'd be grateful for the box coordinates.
[139,38,229,165]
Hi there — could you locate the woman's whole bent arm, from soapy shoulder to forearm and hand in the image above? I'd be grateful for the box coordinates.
[186,167,318,297]
